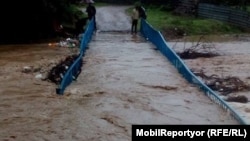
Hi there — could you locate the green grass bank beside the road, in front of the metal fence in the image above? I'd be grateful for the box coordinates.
[147,7,246,35]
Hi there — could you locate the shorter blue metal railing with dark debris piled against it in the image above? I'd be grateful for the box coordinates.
[56,19,94,95]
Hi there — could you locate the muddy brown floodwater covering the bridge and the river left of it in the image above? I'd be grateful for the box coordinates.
[0,5,242,141]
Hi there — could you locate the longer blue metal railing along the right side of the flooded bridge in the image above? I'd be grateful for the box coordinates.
[140,19,247,124]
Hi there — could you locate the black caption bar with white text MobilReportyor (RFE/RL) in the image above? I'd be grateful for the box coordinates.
[132,125,250,141]
